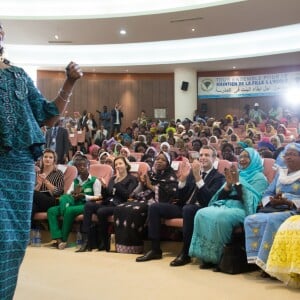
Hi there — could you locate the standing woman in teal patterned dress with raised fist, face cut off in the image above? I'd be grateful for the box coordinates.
[0,24,82,300]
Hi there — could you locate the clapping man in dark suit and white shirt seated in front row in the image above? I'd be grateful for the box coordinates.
[136,146,225,266]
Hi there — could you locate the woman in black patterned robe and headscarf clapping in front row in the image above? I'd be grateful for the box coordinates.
[114,151,178,253]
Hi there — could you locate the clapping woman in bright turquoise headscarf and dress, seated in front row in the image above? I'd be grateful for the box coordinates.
[189,148,268,268]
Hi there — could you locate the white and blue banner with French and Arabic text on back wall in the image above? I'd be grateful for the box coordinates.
[198,71,300,99]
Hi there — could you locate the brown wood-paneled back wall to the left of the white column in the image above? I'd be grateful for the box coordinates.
[37,71,174,129]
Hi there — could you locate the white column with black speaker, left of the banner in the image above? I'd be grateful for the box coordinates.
[174,68,197,120]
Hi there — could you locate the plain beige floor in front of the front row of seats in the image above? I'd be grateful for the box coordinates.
[14,246,300,300]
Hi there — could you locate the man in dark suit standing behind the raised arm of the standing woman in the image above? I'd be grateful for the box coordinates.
[46,121,70,164]
